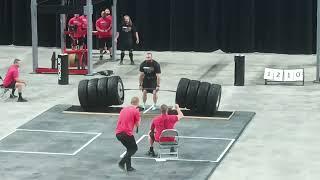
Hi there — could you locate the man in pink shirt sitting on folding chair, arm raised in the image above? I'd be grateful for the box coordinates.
[147,104,183,157]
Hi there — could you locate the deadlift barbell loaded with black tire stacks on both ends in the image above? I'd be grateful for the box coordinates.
[78,76,221,115]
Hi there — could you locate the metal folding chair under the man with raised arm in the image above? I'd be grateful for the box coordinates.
[159,129,179,158]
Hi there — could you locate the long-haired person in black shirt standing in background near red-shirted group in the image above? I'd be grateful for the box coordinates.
[115,15,139,65]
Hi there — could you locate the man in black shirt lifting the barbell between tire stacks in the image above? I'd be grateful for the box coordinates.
[139,53,161,110]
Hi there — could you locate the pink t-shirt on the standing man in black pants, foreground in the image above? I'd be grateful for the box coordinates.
[116,106,140,136]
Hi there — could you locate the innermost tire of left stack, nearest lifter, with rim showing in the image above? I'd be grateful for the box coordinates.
[108,76,124,105]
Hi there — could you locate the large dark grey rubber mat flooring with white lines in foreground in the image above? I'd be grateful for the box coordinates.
[0,105,255,180]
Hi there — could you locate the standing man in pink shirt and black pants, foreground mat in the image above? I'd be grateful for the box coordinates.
[116,97,140,171]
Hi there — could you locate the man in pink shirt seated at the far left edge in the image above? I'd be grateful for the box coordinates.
[3,59,27,102]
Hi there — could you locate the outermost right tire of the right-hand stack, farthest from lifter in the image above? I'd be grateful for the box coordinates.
[206,84,221,116]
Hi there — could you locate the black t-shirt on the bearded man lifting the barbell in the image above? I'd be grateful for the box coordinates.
[140,60,161,79]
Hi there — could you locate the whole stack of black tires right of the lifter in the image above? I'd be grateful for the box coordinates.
[176,78,221,116]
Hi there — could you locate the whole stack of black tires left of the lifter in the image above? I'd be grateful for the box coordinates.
[78,76,124,110]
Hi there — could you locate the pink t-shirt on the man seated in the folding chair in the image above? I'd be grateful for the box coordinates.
[150,114,178,142]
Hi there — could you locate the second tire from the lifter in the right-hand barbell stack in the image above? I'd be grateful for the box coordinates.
[186,80,200,110]
